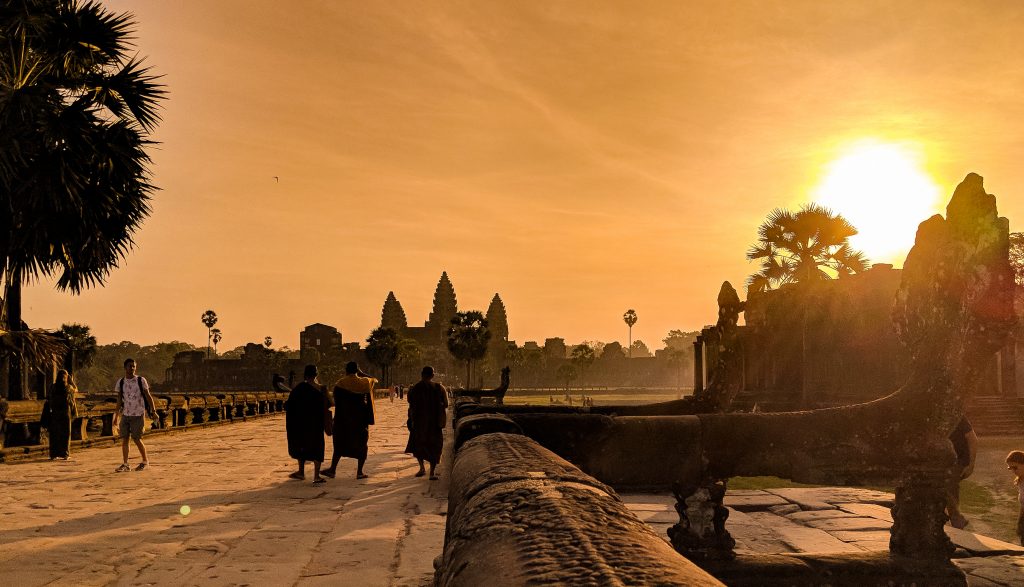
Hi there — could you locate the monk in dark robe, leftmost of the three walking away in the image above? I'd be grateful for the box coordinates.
[285,365,331,486]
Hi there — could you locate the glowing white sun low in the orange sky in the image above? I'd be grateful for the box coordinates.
[812,140,941,265]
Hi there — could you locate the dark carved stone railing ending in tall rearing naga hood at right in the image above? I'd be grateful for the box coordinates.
[436,174,1016,585]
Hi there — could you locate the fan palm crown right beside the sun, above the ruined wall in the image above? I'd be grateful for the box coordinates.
[746,204,869,292]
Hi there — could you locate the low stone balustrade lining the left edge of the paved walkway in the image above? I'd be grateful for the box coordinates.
[0,391,288,460]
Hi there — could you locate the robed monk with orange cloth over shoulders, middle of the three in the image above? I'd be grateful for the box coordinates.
[324,361,377,479]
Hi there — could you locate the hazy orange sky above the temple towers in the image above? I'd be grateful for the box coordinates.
[25,0,1024,349]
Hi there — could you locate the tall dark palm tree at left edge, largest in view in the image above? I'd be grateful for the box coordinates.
[0,0,165,397]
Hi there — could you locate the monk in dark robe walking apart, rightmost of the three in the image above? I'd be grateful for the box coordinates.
[406,366,447,480]
